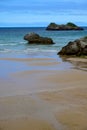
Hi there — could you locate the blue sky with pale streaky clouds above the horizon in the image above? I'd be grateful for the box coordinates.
[0,0,87,27]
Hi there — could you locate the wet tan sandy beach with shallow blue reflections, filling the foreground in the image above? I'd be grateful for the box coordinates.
[0,57,87,130]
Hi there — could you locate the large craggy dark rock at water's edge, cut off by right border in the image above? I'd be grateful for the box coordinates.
[58,37,87,55]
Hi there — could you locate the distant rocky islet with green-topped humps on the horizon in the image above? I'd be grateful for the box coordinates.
[46,22,83,31]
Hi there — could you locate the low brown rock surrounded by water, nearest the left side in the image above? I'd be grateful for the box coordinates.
[24,33,54,44]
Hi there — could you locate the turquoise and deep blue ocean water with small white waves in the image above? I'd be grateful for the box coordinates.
[0,27,87,56]
